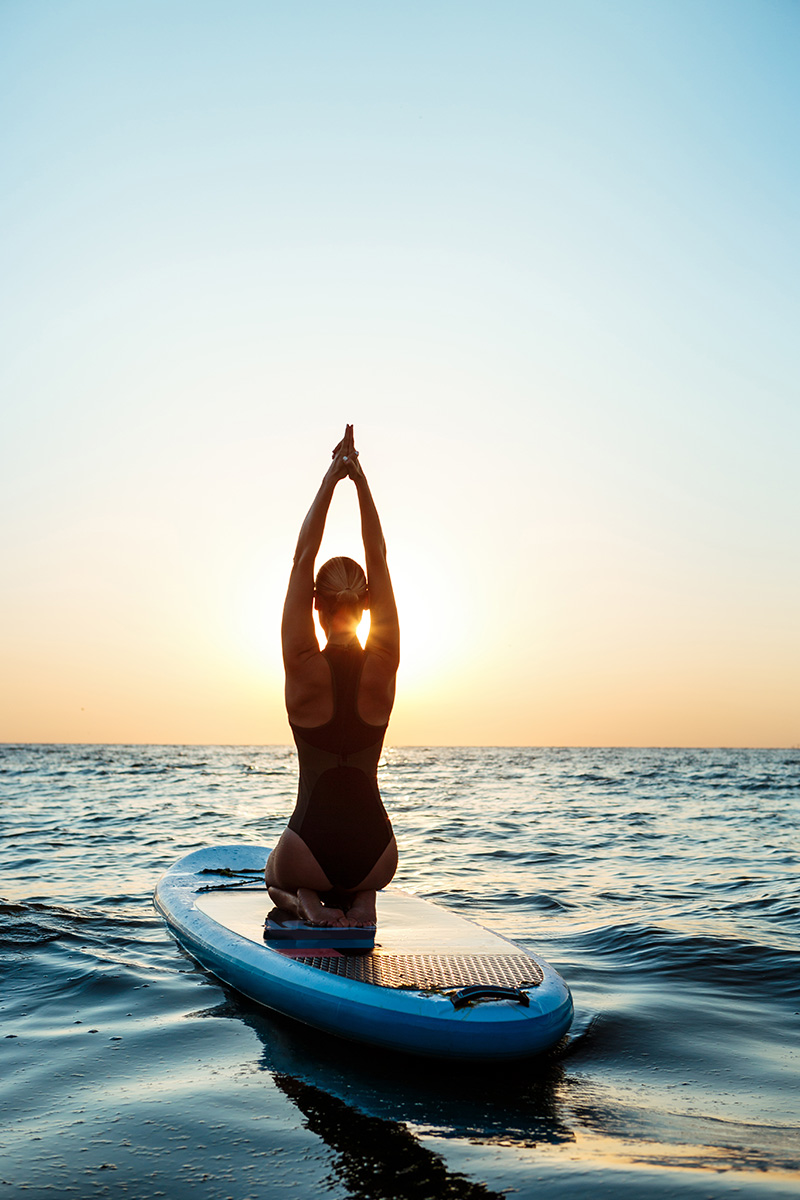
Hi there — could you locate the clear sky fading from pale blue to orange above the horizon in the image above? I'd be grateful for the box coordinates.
[0,0,800,745]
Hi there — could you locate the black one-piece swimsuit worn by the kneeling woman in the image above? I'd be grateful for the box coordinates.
[289,640,392,890]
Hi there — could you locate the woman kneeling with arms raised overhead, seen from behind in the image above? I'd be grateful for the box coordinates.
[265,425,399,926]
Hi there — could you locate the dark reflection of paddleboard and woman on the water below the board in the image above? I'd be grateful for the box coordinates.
[193,989,575,1200]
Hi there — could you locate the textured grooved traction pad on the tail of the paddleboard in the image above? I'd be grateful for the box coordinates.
[281,952,545,991]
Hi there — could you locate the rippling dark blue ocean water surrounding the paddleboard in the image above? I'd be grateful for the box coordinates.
[0,745,800,1200]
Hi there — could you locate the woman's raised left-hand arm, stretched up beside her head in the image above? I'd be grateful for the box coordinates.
[281,439,349,671]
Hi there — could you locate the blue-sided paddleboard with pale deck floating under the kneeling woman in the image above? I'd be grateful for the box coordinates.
[155,845,572,1061]
